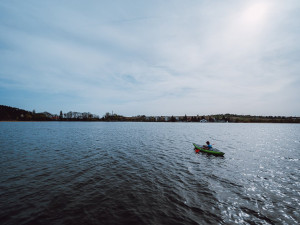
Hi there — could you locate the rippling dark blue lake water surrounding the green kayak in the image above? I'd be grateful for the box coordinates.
[0,122,300,225]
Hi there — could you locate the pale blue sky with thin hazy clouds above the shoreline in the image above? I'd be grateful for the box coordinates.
[0,0,300,116]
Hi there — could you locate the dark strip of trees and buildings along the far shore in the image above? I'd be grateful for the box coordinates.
[0,105,300,123]
